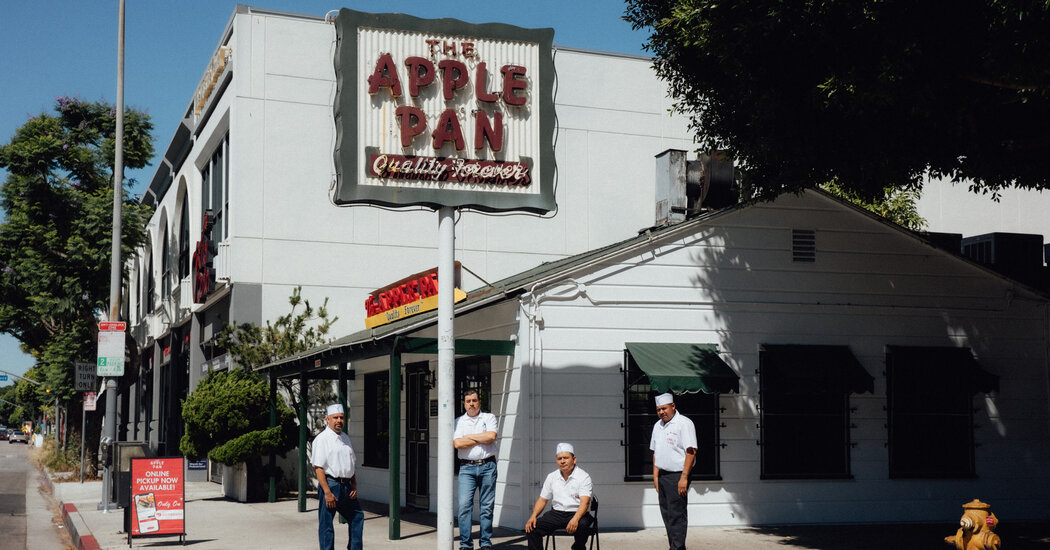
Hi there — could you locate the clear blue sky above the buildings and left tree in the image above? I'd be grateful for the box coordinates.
[0,0,646,385]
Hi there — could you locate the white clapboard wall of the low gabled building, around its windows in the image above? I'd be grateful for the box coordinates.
[493,193,1050,527]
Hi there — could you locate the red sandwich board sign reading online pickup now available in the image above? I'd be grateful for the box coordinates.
[128,457,186,545]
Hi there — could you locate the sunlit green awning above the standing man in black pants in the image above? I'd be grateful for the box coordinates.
[627,342,740,394]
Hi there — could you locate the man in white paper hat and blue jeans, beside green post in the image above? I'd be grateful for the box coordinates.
[311,403,364,550]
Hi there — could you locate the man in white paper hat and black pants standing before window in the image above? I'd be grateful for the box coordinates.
[649,394,696,550]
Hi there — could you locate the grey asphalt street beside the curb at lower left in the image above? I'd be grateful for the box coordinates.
[0,441,72,550]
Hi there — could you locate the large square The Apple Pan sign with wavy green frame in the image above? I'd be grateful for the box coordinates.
[334,8,555,213]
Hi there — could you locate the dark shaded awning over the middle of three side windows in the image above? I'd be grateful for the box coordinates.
[762,344,875,394]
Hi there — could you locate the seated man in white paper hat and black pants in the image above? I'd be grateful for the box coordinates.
[525,443,593,550]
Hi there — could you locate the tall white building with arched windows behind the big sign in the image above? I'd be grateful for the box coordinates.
[119,6,691,463]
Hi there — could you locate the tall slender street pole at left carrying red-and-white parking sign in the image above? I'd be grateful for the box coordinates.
[102,0,124,512]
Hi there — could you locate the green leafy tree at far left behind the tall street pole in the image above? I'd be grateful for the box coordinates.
[0,98,153,459]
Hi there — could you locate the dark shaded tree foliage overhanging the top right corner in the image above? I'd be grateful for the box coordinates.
[625,0,1050,199]
